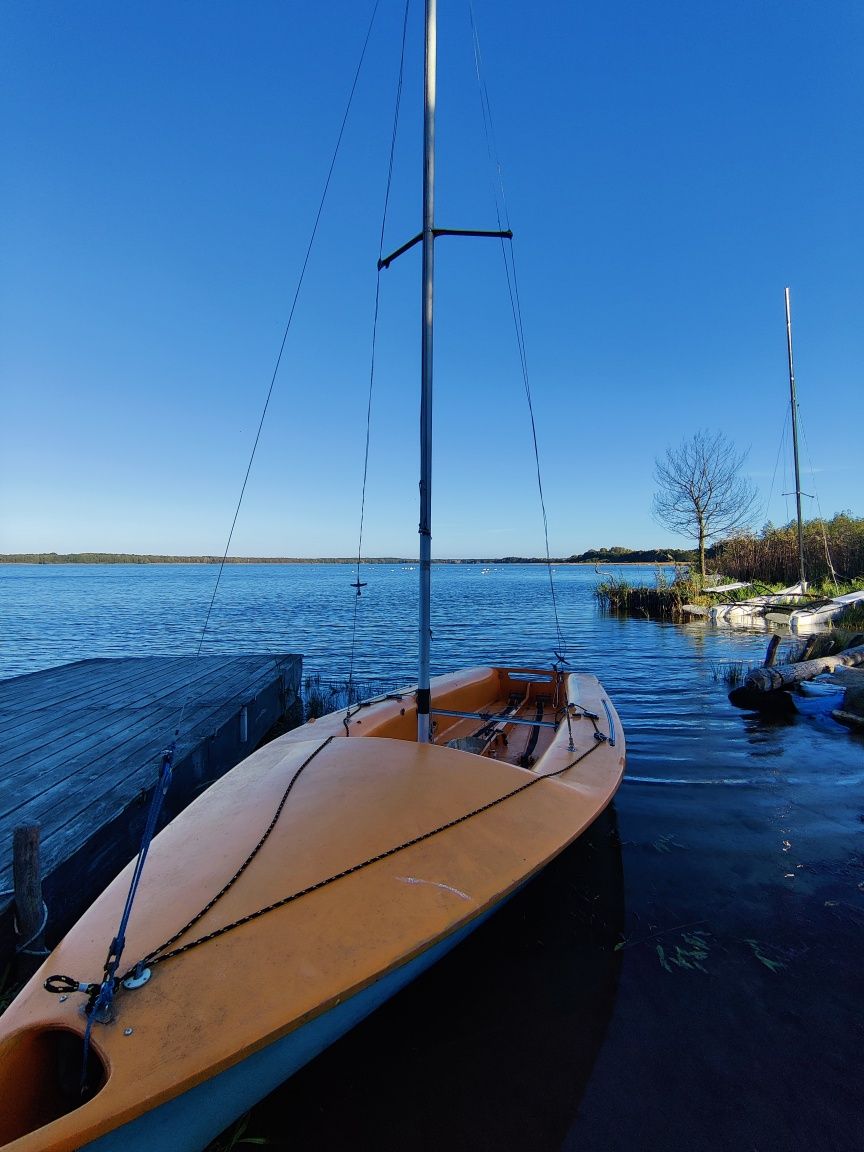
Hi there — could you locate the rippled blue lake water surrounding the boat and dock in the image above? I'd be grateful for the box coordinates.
[0,564,864,1152]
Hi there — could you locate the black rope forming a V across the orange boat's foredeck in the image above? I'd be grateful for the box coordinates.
[120,726,606,968]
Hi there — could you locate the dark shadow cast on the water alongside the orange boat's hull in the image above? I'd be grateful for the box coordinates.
[224,810,624,1152]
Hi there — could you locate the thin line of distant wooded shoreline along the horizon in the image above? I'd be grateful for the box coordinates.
[0,552,692,567]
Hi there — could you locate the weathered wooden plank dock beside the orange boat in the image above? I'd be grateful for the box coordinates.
[0,654,302,975]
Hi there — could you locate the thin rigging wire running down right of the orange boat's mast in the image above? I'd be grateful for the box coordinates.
[468,0,567,664]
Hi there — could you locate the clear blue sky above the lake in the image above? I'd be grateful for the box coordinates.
[0,0,864,556]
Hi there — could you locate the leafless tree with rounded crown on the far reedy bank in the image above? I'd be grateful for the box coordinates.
[654,431,757,581]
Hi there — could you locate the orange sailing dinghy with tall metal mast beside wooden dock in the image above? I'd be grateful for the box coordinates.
[0,0,624,1152]
